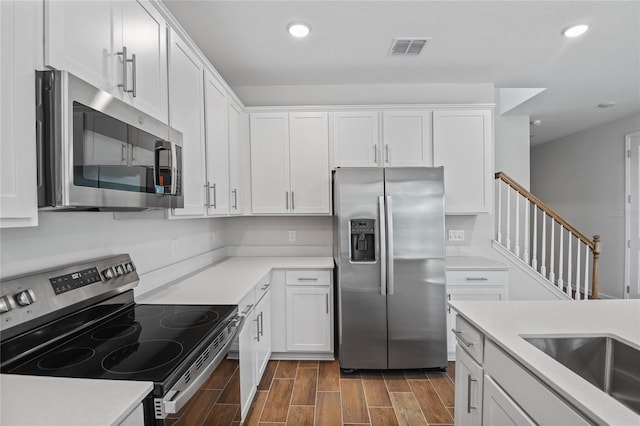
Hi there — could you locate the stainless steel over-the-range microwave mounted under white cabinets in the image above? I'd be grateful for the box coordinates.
[36,71,184,211]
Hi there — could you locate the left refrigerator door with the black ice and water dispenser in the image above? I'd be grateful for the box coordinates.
[333,168,387,369]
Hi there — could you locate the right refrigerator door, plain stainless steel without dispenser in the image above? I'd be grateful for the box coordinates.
[385,167,447,369]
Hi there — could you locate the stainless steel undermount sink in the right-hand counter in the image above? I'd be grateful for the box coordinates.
[523,336,640,414]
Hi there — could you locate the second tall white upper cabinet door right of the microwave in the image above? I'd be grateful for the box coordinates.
[204,71,229,215]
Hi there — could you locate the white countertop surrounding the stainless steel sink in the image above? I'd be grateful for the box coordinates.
[449,300,640,425]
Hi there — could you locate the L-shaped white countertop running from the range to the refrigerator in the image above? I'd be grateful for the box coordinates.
[136,257,334,305]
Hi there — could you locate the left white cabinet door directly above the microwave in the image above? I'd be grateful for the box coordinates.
[44,1,115,93]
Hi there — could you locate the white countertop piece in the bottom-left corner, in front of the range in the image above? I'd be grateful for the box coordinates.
[0,374,153,426]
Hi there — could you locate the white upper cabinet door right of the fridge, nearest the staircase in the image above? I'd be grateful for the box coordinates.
[433,110,493,214]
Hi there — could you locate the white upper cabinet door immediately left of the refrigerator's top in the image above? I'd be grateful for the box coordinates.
[289,112,331,214]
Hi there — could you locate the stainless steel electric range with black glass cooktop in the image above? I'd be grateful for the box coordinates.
[0,254,244,425]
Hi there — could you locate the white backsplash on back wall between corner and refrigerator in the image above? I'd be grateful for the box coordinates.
[226,216,333,256]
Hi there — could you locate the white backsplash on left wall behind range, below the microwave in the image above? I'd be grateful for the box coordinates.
[0,211,227,278]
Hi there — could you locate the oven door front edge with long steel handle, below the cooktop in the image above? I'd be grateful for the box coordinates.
[154,315,245,420]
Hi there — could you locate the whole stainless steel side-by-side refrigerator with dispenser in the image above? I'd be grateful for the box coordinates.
[333,167,447,370]
